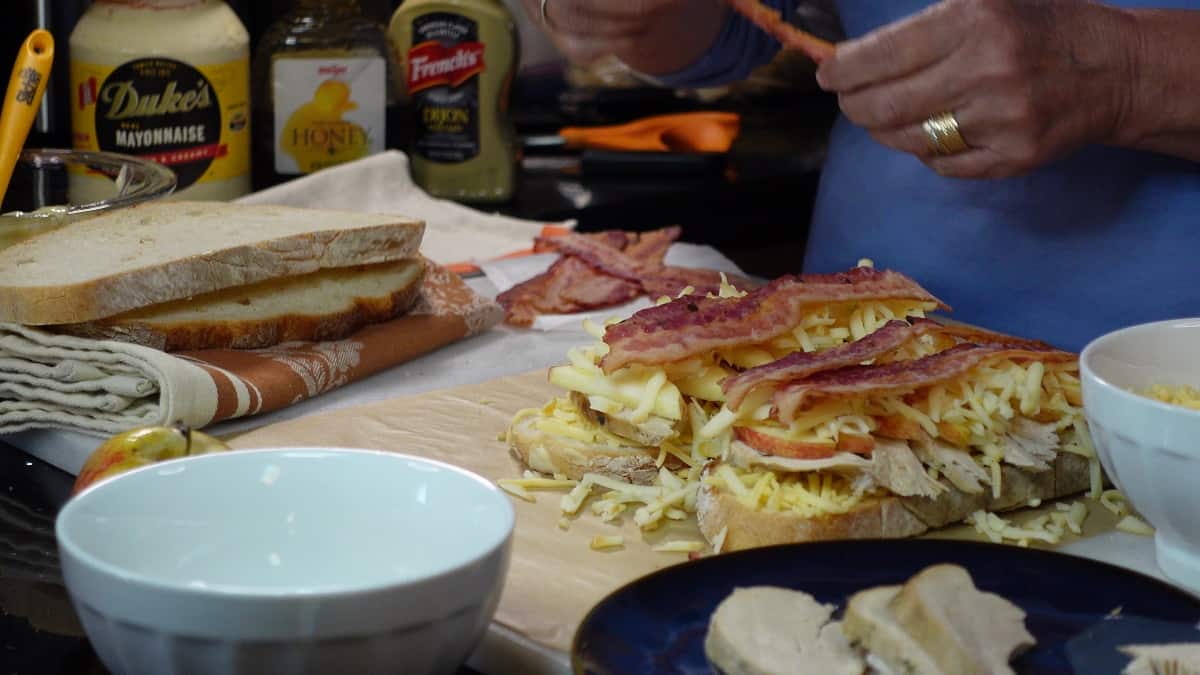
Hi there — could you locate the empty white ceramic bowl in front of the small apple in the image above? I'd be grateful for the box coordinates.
[56,448,514,675]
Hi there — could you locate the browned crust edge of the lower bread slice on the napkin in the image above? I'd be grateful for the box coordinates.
[53,258,426,352]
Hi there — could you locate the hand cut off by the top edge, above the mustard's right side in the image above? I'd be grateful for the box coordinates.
[522,0,725,74]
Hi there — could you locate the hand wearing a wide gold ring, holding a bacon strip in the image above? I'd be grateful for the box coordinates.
[817,0,1136,178]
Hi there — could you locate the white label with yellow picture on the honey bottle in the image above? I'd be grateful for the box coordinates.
[271,56,388,174]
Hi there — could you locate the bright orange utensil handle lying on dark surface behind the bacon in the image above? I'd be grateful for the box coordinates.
[558,112,740,153]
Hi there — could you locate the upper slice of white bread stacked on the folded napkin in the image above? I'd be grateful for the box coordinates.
[0,201,425,325]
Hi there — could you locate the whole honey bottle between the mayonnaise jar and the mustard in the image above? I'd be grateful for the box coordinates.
[253,0,400,189]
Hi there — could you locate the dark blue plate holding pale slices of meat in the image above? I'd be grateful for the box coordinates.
[571,539,1200,675]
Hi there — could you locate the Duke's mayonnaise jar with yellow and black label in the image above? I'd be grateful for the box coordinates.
[71,0,250,202]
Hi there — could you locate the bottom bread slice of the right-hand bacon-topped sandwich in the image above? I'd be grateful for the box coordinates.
[696,452,1090,551]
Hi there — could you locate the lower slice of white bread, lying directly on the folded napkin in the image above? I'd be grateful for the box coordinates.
[52,258,425,352]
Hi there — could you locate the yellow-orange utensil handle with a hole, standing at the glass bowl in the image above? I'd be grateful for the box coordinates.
[0,29,54,202]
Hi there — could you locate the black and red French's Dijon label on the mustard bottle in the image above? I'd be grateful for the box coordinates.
[407,12,487,163]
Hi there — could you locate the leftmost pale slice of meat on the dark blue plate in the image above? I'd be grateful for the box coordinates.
[704,586,865,675]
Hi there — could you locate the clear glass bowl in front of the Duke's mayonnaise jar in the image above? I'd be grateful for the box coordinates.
[0,149,175,249]
